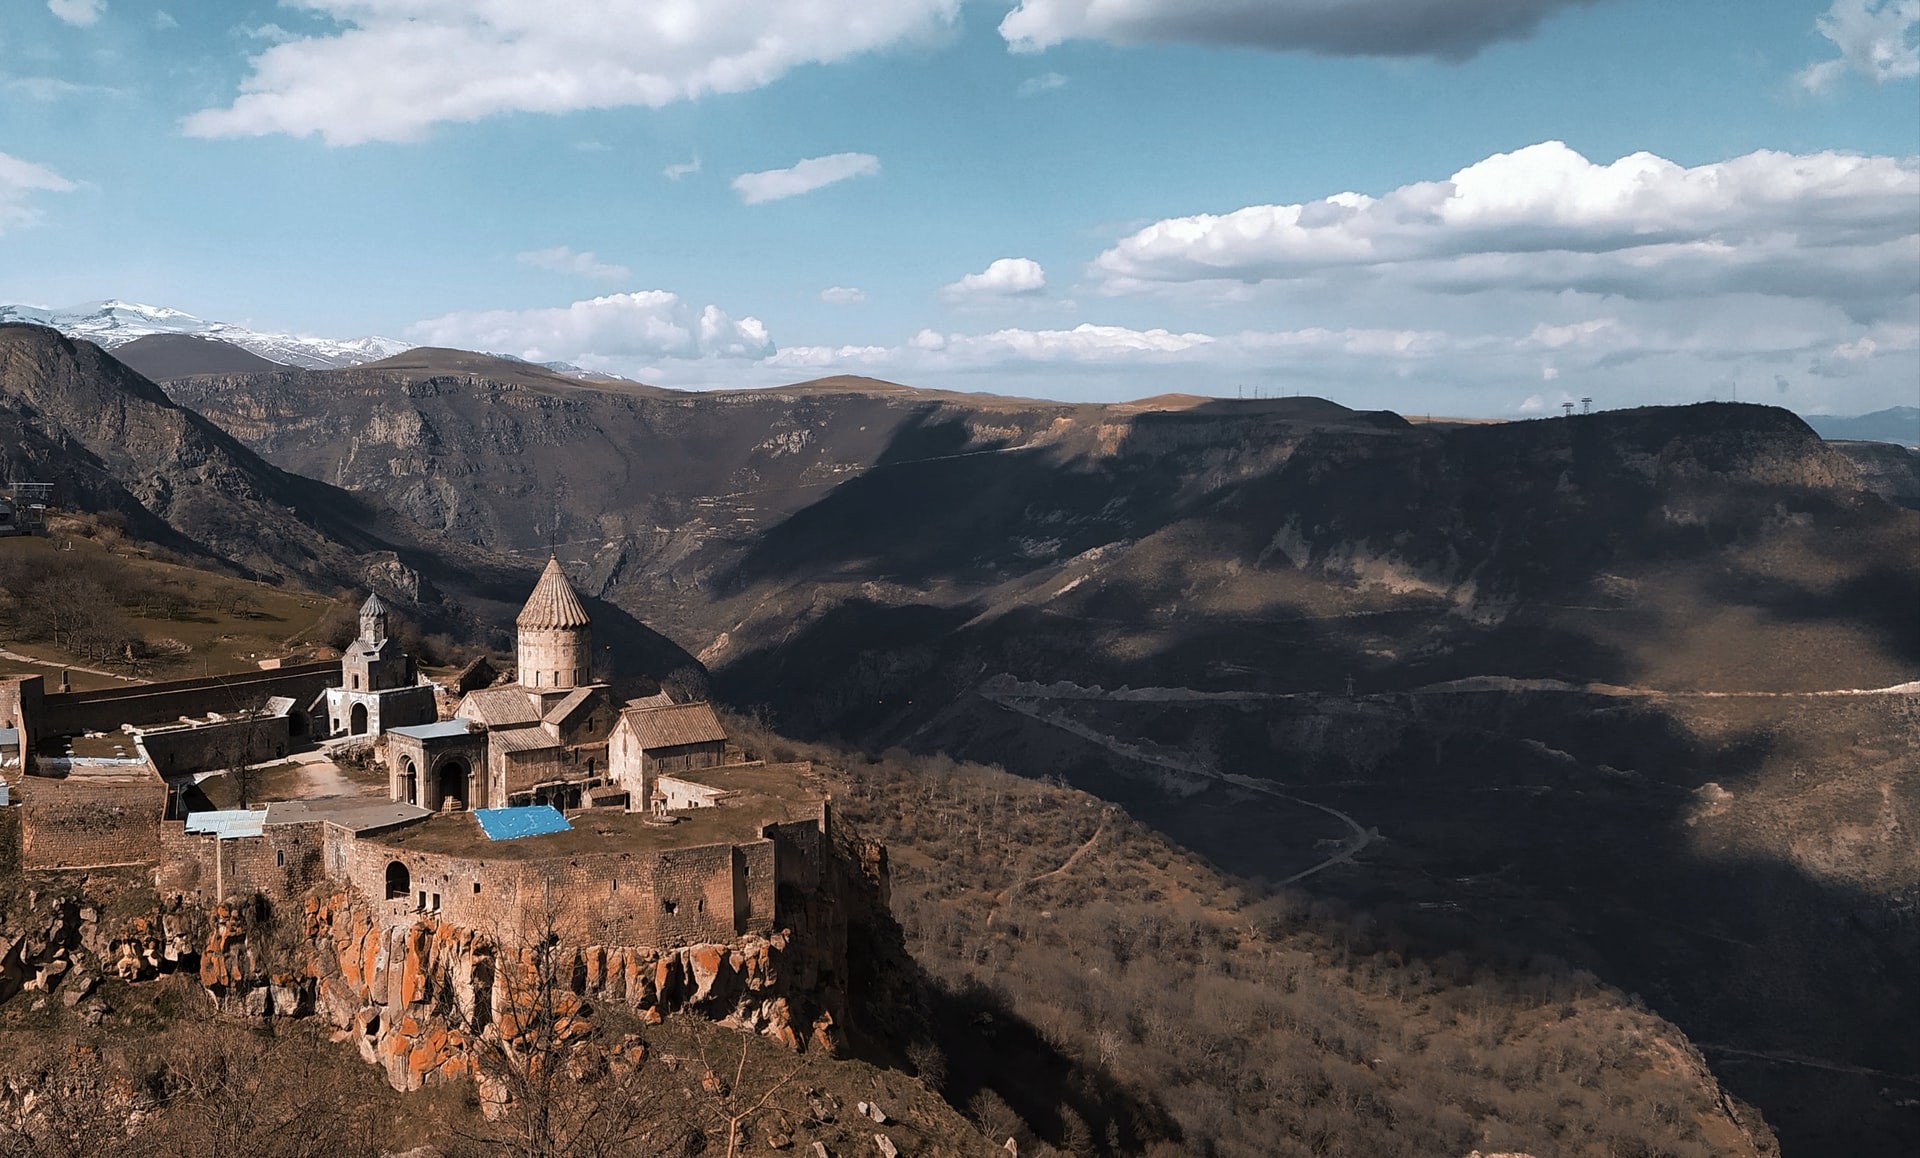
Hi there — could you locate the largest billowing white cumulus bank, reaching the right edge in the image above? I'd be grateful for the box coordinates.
[1092,140,1920,313]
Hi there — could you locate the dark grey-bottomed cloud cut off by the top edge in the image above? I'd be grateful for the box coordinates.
[1000,0,1597,60]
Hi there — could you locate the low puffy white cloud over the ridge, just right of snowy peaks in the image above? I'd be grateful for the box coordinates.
[407,290,774,369]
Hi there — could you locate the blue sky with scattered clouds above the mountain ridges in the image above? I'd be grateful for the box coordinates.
[0,0,1920,415]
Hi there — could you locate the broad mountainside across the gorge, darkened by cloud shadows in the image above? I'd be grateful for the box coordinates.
[145,361,1920,1154]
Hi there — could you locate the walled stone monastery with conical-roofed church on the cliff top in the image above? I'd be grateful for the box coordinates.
[0,559,856,990]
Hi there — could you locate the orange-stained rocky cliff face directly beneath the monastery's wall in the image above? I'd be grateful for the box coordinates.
[187,893,839,1104]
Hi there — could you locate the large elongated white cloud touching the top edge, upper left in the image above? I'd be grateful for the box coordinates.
[183,0,960,144]
